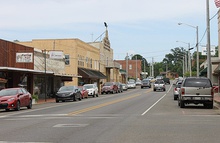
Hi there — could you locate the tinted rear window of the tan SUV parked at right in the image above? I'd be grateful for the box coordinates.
[183,78,212,88]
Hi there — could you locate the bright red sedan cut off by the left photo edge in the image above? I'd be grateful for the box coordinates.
[0,88,32,111]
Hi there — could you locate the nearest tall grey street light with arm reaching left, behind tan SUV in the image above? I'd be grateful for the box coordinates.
[178,23,199,77]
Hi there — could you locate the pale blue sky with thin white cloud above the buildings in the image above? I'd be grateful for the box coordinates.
[0,0,218,62]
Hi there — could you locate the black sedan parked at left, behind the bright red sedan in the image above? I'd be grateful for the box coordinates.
[55,86,81,103]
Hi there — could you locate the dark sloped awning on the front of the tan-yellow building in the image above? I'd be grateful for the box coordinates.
[78,68,106,79]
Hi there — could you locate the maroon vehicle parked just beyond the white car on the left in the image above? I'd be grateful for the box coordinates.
[101,82,118,94]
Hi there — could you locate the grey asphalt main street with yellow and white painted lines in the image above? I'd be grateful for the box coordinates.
[0,85,220,143]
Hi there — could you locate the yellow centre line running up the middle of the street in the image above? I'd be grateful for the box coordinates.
[68,94,141,116]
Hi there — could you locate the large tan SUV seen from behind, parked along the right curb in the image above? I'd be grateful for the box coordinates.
[178,77,214,109]
